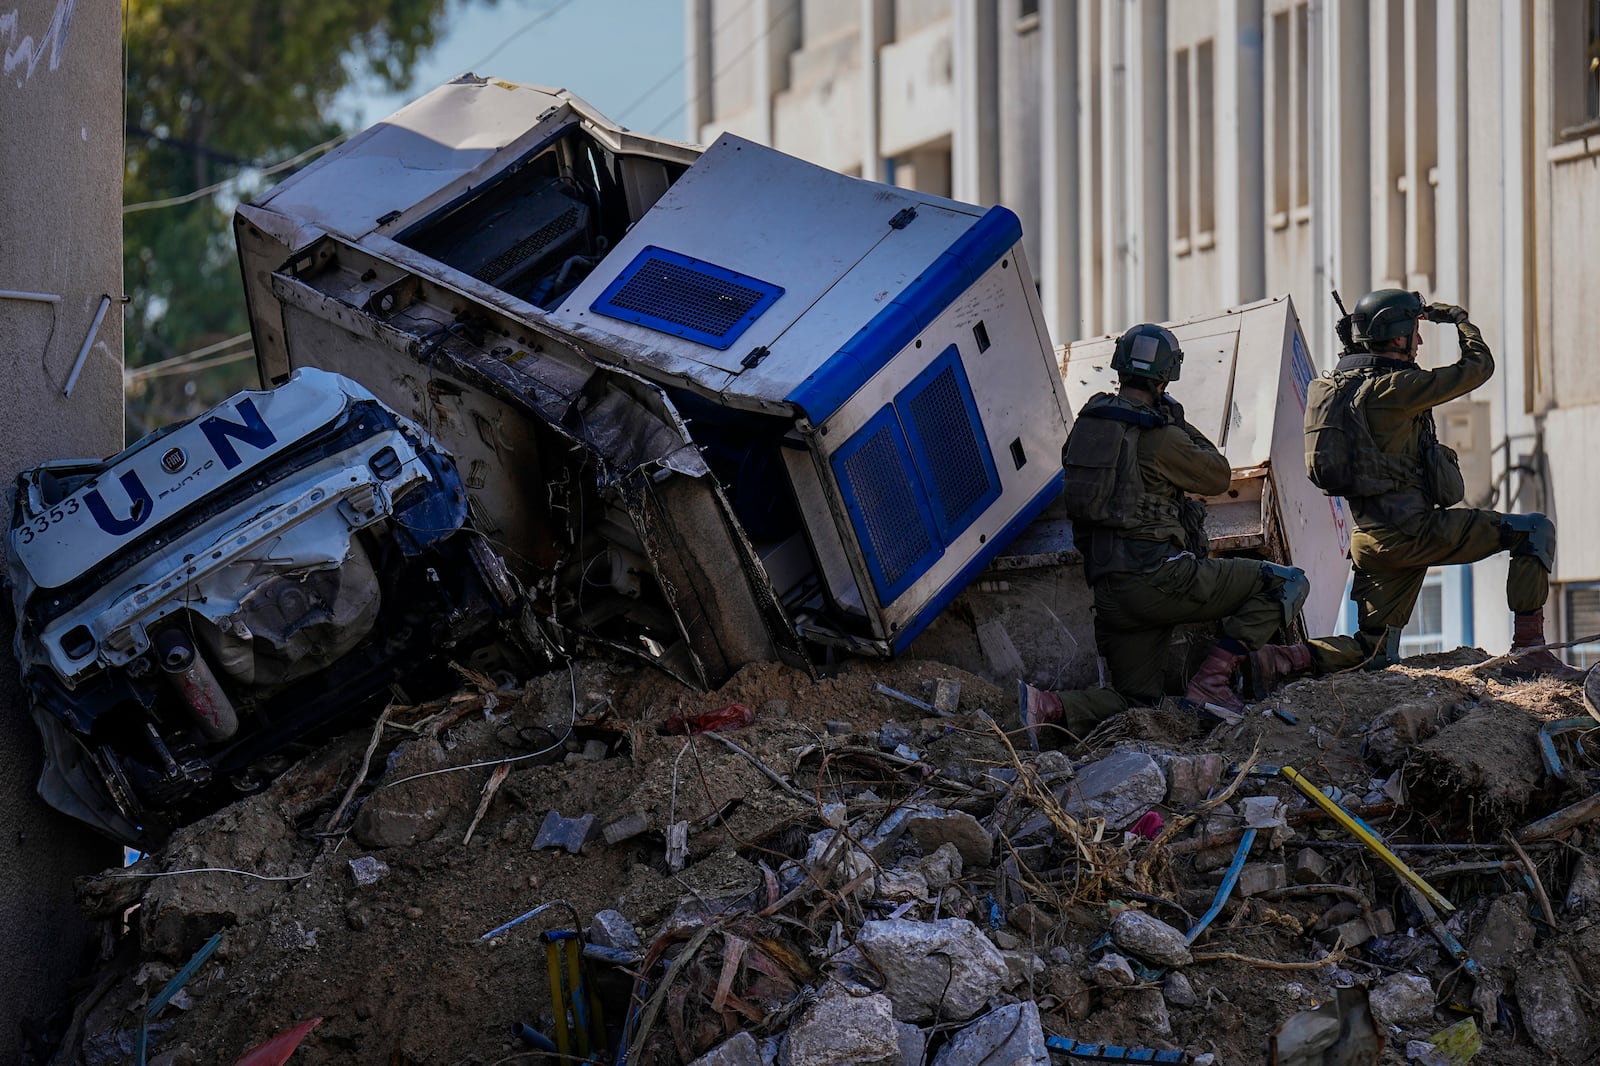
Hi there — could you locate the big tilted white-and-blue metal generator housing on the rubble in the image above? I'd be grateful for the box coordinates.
[235,77,1069,685]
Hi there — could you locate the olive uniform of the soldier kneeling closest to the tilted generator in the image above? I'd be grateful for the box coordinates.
[1045,394,1299,736]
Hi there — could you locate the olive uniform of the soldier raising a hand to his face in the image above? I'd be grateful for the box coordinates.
[1310,322,1554,669]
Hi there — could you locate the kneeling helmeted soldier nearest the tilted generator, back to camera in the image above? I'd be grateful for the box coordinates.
[1018,323,1314,746]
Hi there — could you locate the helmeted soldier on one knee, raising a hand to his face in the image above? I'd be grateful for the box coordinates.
[1306,288,1582,680]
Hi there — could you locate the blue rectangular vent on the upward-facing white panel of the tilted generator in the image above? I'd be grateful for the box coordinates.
[590,246,784,351]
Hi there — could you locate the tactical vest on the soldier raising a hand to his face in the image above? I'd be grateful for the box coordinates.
[1306,352,1434,499]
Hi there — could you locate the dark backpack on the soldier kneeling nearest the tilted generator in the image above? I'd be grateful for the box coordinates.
[1061,392,1163,530]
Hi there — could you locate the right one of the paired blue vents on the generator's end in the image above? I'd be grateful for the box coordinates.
[894,344,1000,544]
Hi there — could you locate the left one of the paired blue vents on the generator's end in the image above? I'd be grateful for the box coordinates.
[829,405,944,603]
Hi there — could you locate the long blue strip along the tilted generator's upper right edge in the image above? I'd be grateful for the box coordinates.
[787,206,1022,423]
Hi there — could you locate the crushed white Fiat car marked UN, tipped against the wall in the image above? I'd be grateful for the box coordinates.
[8,368,520,845]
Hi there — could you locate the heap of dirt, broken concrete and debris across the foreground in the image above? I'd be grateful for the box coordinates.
[37,650,1600,1066]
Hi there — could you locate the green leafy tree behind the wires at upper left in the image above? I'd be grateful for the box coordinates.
[123,0,480,435]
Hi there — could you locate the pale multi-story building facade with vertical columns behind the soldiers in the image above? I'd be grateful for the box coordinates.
[686,0,1600,661]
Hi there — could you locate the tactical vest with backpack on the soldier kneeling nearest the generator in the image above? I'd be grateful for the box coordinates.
[1061,392,1189,583]
